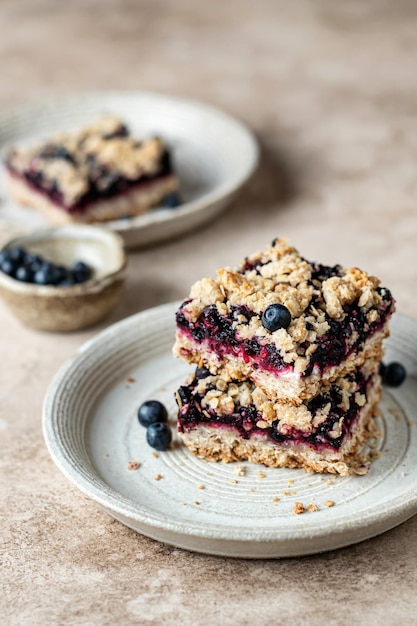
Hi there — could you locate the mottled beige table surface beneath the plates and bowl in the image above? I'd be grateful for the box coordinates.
[0,0,417,626]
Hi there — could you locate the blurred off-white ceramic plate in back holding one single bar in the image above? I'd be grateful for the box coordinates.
[0,92,258,247]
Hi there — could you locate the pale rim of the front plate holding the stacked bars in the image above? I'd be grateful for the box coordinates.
[42,301,417,556]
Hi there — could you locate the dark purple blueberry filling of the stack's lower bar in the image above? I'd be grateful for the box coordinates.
[177,371,375,450]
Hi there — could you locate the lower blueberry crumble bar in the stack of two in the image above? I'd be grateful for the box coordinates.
[176,364,381,475]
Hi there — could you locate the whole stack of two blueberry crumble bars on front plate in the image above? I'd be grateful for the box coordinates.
[174,239,394,475]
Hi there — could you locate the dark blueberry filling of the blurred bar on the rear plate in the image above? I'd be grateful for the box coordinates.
[6,150,172,212]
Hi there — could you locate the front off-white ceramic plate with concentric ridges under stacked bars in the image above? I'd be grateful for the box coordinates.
[43,304,417,558]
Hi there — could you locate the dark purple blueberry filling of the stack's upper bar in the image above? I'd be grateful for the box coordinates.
[176,288,393,377]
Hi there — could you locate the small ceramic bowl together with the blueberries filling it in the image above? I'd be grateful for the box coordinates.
[0,224,126,332]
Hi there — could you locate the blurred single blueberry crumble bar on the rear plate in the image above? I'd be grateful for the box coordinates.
[5,117,179,223]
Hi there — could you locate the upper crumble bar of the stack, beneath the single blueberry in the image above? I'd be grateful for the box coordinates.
[174,240,395,404]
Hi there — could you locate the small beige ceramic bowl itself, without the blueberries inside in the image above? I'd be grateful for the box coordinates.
[0,225,126,331]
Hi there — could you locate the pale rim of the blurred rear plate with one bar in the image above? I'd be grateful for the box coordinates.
[0,89,260,240]
